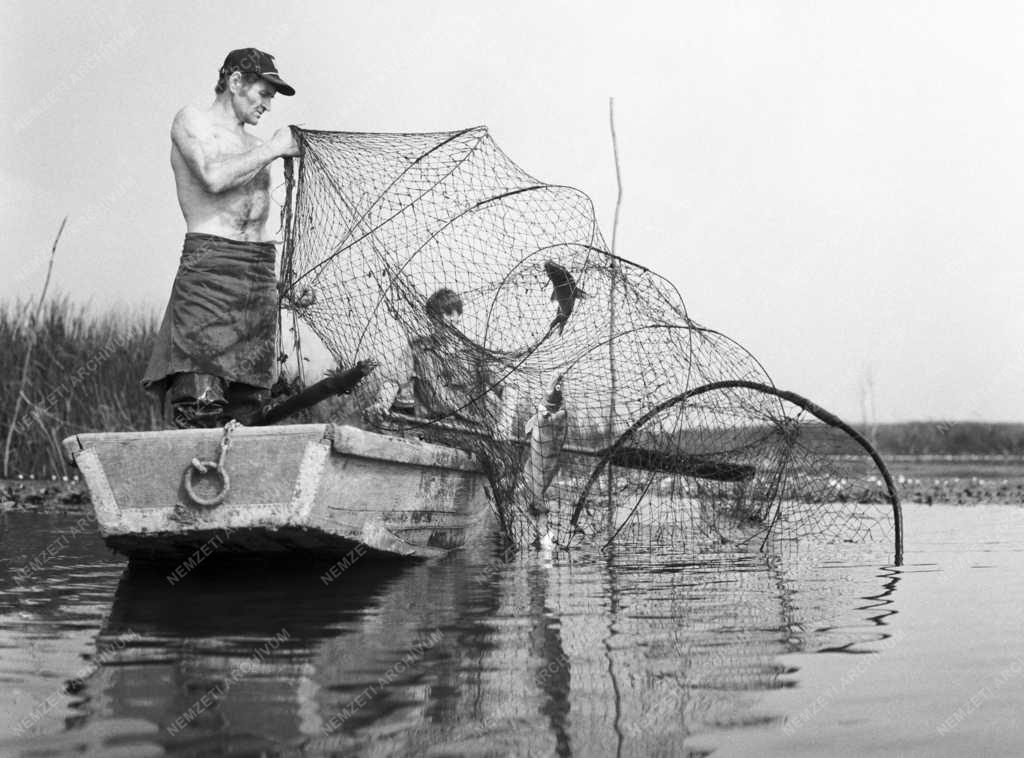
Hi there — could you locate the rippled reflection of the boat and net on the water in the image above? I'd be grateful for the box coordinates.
[68,532,892,756]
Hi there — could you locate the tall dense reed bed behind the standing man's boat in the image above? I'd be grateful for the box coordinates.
[0,295,163,478]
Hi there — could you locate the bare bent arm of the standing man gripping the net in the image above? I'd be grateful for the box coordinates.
[171,108,298,195]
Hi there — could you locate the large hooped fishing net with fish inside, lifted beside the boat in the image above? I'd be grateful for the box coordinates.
[282,127,901,559]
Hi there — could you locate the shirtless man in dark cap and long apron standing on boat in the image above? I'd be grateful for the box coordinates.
[142,47,298,427]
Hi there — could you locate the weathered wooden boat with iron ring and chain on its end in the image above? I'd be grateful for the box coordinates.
[63,424,492,558]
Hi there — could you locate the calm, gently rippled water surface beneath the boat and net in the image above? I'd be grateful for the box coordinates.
[0,497,1024,756]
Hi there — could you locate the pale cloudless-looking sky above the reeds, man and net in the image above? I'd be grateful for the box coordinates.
[0,0,1024,421]
